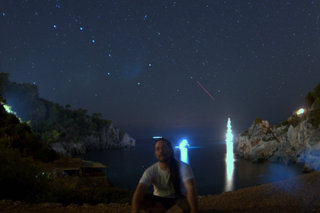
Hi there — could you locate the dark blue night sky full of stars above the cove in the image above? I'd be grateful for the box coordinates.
[0,0,320,140]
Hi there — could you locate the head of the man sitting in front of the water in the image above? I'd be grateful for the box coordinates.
[154,138,174,162]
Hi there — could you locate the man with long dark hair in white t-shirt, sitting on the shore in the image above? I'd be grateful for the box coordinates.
[132,138,198,213]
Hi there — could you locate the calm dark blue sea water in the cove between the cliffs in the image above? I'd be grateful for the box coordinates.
[80,140,302,195]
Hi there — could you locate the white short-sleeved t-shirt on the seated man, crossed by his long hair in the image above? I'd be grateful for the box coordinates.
[139,162,194,198]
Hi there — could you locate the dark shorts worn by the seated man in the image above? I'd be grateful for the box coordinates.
[142,194,190,212]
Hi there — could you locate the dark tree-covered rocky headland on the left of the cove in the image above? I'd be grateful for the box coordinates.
[0,73,135,155]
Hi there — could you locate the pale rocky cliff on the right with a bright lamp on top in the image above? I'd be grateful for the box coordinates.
[236,84,320,170]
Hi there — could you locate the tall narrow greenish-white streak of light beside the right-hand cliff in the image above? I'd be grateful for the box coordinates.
[224,118,234,191]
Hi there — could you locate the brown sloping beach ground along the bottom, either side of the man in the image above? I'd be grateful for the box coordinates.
[0,172,320,213]
